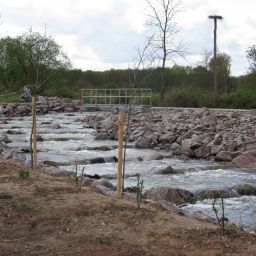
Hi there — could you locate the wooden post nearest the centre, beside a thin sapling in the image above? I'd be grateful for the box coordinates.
[117,111,125,193]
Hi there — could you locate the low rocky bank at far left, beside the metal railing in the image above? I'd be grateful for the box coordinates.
[0,96,80,116]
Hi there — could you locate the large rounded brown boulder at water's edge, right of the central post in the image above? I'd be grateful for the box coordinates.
[145,187,194,204]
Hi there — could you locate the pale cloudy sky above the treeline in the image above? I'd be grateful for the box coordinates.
[0,0,256,75]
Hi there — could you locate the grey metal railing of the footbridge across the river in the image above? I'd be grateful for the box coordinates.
[82,88,152,109]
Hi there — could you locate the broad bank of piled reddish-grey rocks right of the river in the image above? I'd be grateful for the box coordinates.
[84,108,256,168]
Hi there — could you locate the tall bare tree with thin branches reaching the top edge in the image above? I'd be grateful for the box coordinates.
[146,0,184,100]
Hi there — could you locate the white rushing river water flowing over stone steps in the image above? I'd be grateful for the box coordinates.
[0,113,256,229]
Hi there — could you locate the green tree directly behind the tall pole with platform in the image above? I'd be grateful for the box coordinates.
[209,53,231,94]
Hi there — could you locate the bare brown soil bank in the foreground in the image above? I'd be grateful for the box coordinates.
[0,160,256,256]
